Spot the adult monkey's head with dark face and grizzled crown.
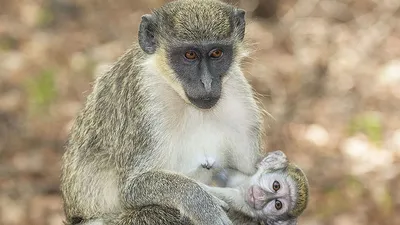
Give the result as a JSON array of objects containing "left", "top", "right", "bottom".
[{"left": 139, "top": 0, "right": 245, "bottom": 109}]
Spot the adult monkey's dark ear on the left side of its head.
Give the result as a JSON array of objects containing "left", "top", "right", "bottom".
[{"left": 139, "top": 14, "right": 157, "bottom": 54}]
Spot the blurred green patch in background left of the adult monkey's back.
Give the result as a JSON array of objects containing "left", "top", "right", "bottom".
[{"left": 26, "top": 70, "right": 57, "bottom": 111}]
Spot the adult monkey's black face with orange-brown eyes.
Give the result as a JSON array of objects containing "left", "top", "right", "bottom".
[{"left": 168, "top": 43, "right": 233, "bottom": 109}]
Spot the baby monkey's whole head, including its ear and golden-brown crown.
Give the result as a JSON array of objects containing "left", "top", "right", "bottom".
[{"left": 245, "top": 151, "right": 309, "bottom": 225}]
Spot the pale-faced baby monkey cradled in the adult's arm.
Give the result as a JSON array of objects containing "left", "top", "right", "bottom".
[{"left": 202, "top": 150, "right": 309, "bottom": 225}]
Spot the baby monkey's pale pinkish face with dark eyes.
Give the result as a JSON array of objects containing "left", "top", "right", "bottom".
[{"left": 245, "top": 169, "right": 296, "bottom": 224}]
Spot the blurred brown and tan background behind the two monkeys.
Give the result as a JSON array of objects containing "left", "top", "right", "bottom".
[{"left": 0, "top": 0, "right": 400, "bottom": 225}]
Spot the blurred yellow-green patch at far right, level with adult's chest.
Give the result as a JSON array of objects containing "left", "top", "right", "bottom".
[{"left": 349, "top": 112, "right": 383, "bottom": 145}]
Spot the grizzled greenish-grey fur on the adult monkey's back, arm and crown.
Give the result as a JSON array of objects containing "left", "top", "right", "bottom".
[{"left": 61, "top": 0, "right": 261, "bottom": 225}]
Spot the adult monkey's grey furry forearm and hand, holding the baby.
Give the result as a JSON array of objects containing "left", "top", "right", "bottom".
[{"left": 123, "top": 171, "right": 232, "bottom": 225}]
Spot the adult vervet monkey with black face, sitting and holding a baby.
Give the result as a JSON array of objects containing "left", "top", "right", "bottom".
[{"left": 61, "top": 0, "right": 262, "bottom": 225}]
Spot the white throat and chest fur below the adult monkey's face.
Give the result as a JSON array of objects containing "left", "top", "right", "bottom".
[{"left": 144, "top": 55, "right": 260, "bottom": 182}]
